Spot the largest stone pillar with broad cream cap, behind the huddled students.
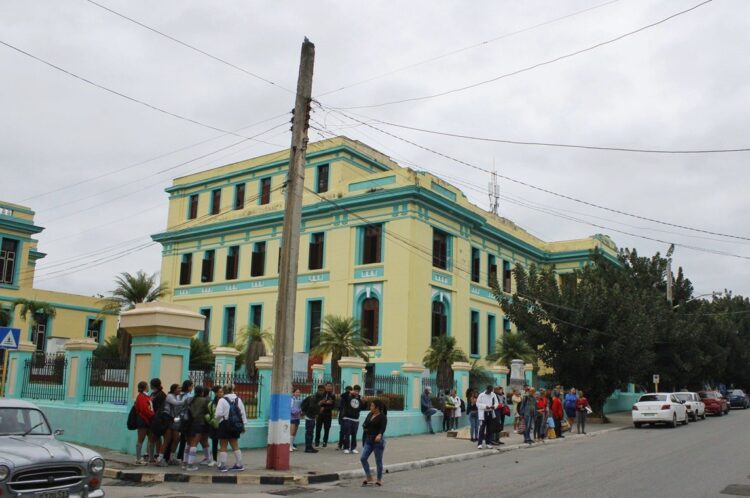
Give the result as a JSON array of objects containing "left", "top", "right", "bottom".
[{"left": 120, "top": 302, "right": 205, "bottom": 398}]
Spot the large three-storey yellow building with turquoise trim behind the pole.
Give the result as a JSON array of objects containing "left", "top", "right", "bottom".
[{"left": 153, "top": 137, "right": 616, "bottom": 374}]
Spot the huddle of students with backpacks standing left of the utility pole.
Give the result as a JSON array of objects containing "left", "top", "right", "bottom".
[{"left": 128, "top": 378, "right": 247, "bottom": 472}]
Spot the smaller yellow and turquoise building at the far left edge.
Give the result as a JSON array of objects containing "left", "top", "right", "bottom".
[{"left": 0, "top": 201, "right": 117, "bottom": 353}]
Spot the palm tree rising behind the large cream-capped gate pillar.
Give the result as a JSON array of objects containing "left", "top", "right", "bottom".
[{"left": 102, "top": 270, "right": 169, "bottom": 358}]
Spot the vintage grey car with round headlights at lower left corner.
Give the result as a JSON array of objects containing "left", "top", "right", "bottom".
[{"left": 0, "top": 399, "right": 104, "bottom": 498}]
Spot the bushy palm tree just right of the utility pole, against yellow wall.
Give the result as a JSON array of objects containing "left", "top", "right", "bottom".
[{"left": 310, "top": 315, "right": 370, "bottom": 379}]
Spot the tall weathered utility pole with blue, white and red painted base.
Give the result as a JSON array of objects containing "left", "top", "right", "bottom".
[{"left": 266, "top": 38, "right": 315, "bottom": 470}]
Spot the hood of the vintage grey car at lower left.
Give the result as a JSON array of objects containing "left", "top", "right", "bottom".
[{"left": 0, "top": 436, "right": 99, "bottom": 468}]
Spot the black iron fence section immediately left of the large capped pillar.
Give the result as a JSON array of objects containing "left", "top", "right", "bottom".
[{"left": 83, "top": 358, "right": 130, "bottom": 405}]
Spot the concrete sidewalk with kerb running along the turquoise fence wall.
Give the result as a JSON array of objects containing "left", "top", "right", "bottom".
[{"left": 98, "top": 412, "right": 631, "bottom": 484}]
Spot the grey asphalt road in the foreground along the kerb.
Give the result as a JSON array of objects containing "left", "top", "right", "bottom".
[{"left": 107, "top": 410, "right": 750, "bottom": 498}]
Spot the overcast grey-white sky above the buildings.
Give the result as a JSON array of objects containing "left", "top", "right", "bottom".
[{"left": 0, "top": 0, "right": 750, "bottom": 295}]
